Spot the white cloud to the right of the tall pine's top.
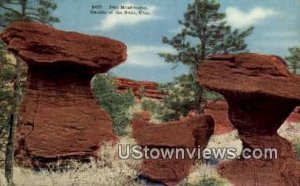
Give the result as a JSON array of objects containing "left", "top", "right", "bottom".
[{"left": 225, "top": 7, "right": 277, "bottom": 28}]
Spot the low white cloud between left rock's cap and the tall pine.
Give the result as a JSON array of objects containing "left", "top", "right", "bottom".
[{"left": 124, "top": 45, "right": 174, "bottom": 67}]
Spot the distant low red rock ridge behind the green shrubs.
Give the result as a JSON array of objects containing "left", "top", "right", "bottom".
[{"left": 115, "top": 77, "right": 164, "bottom": 100}]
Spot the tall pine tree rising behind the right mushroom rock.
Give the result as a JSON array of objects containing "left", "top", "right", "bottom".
[{"left": 159, "top": 0, "right": 254, "bottom": 113}]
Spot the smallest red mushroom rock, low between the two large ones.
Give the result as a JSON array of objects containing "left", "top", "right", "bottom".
[{"left": 132, "top": 115, "right": 214, "bottom": 185}]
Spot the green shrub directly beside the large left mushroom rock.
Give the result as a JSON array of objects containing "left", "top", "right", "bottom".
[{"left": 92, "top": 75, "right": 134, "bottom": 136}]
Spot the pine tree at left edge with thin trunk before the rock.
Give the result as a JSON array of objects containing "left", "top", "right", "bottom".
[{"left": 0, "top": 0, "right": 59, "bottom": 186}]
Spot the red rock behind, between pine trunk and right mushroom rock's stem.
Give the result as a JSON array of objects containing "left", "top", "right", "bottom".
[{"left": 204, "top": 100, "right": 234, "bottom": 135}]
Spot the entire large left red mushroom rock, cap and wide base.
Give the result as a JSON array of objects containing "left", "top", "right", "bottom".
[{"left": 1, "top": 22, "right": 126, "bottom": 167}]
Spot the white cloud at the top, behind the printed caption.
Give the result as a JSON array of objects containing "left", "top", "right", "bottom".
[{"left": 95, "top": 2, "right": 159, "bottom": 31}]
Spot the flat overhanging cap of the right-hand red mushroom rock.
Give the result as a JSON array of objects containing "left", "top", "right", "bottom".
[{"left": 198, "top": 53, "right": 300, "bottom": 101}]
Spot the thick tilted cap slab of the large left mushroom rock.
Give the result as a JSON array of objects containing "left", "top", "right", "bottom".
[{"left": 0, "top": 22, "right": 127, "bottom": 72}]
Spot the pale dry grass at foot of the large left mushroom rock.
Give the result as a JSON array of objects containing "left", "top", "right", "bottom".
[{"left": 0, "top": 138, "right": 142, "bottom": 186}]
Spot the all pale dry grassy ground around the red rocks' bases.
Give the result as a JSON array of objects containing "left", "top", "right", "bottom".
[{"left": 0, "top": 124, "right": 300, "bottom": 186}]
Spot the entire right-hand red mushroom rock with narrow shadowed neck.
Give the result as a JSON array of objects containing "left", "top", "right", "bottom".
[{"left": 198, "top": 54, "right": 300, "bottom": 185}]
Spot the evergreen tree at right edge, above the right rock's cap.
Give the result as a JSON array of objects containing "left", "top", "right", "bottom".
[{"left": 285, "top": 47, "right": 300, "bottom": 75}]
